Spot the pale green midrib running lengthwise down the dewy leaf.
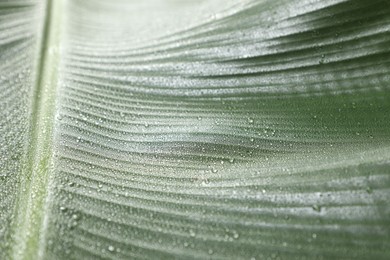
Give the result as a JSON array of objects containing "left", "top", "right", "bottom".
[{"left": 10, "top": 0, "right": 62, "bottom": 259}]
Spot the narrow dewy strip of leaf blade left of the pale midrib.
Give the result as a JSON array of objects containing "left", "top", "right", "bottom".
[{"left": 0, "top": 0, "right": 42, "bottom": 259}]
